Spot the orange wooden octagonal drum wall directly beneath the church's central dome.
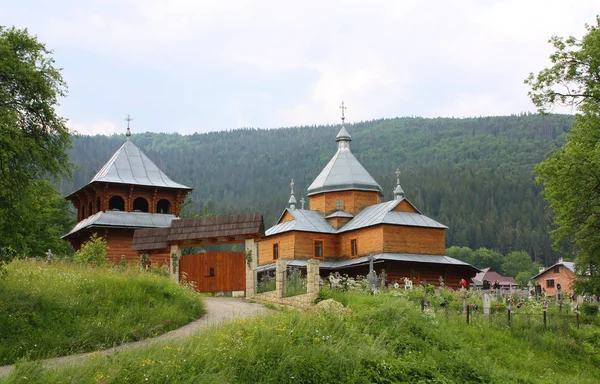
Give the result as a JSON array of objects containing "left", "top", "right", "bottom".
[{"left": 308, "top": 191, "right": 381, "bottom": 216}]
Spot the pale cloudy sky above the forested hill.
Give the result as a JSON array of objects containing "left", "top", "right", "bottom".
[{"left": 0, "top": 0, "right": 600, "bottom": 135}]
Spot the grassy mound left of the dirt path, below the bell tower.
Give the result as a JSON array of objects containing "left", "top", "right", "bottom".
[{"left": 0, "top": 262, "right": 205, "bottom": 365}]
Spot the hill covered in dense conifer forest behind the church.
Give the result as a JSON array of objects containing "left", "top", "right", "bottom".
[{"left": 60, "top": 114, "right": 573, "bottom": 264}]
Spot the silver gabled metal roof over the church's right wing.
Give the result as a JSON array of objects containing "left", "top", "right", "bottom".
[{"left": 338, "top": 199, "right": 448, "bottom": 233}]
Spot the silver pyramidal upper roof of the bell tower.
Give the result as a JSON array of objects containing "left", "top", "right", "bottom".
[{"left": 90, "top": 140, "right": 191, "bottom": 189}]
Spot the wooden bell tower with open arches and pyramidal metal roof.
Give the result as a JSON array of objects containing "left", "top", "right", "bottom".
[{"left": 63, "top": 121, "right": 192, "bottom": 264}]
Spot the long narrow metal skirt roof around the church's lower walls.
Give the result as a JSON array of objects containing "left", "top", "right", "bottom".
[{"left": 256, "top": 253, "right": 478, "bottom": 272}]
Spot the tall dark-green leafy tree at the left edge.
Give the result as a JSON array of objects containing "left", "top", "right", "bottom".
[{"left": 0, "top": 26, "right": 70, "bottom": 253}]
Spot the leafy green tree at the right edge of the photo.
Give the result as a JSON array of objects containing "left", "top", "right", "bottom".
[{"left": 526, "top": 17, "right": 600, "bottom": 294}]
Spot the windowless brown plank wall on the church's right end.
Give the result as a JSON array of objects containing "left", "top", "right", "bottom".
[{"left": 383, "top": 225, "right": 446, "bottom": 255}]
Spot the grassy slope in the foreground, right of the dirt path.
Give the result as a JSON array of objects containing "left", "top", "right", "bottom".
[{"left": 6, "top": 293, "right": 600, "bottom": 383}]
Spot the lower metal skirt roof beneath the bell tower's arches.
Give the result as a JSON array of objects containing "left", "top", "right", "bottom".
[{"left": 63, "top": 211, "right": 177, "bottom": 238}]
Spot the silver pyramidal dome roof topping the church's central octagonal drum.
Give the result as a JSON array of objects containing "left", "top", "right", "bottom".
[{"left": 308, "top": 125, "right": 383, "bottom": 196}]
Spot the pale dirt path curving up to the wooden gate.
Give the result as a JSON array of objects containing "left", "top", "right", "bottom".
[{"left": 0, "top": 297, "right": 269, "bottom": 378}]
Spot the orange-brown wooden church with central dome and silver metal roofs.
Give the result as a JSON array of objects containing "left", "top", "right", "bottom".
[{"left": 258, "top": 105, "right": 478, "bottom": 288}]
